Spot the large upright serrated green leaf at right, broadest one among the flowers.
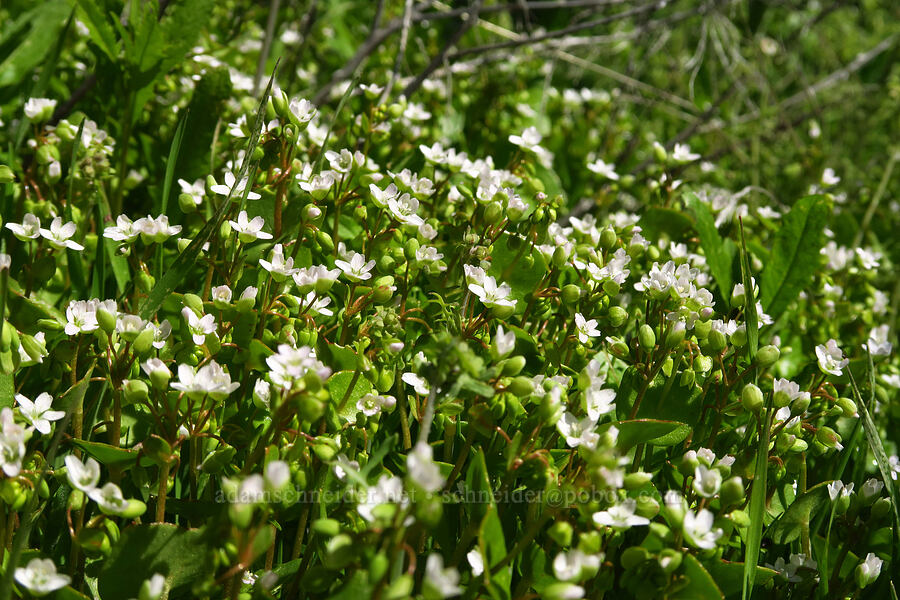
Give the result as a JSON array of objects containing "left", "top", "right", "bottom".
[{"left": 760, "top": 195, "right": 831, "bottom": 319}]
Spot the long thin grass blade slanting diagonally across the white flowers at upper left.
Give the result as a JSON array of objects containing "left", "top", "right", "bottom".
[{"left": 140, "top": 63, "right": 278, "bottom": 319}]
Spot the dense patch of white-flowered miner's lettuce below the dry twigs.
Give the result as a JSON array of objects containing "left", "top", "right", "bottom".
[{"left": 0, "top": 1, "right": 900, "bottom": 600}]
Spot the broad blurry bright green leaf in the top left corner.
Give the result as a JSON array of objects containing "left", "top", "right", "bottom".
[{"left": 0, "top": 0, "right": 72, "bottom": 88}]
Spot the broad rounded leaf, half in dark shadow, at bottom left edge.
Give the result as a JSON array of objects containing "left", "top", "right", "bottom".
[{"left": 99, "top": 523, "right": 220, "bottom": 598}]
